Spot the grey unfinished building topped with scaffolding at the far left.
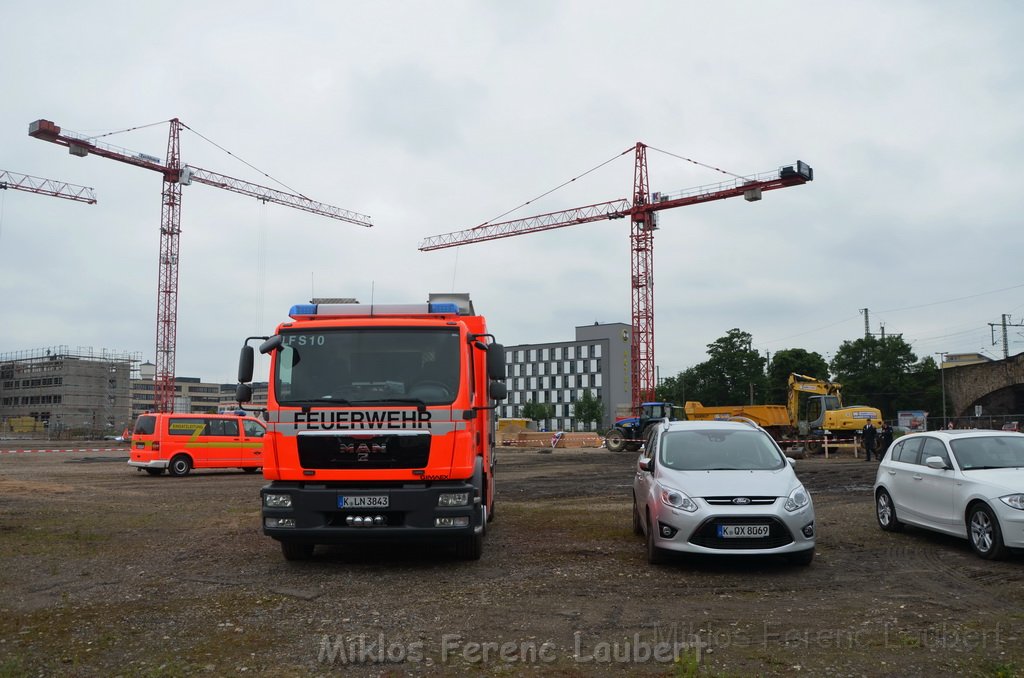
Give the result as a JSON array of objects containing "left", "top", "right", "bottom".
[{"left": 0, "top": 346, "right": 141, "bottom": 438}]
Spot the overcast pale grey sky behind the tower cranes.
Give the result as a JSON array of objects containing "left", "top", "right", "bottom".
[{"left": 0, "top": 0, "right": 1024, "bottom": 382}]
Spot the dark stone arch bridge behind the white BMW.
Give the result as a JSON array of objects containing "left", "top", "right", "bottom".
[{"left": 943, "top": 353, "right": 1024, "bottom": 417}]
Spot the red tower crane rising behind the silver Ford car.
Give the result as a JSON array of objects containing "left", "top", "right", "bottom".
[{"left": 420, "top": 141, "right": 814, "bottom": 411}]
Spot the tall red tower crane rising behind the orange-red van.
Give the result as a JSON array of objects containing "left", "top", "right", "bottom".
[{"left": 29, "top": 118, "right": 373, "bottom": 412}]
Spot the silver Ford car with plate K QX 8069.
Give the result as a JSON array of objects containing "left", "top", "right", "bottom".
[{"left": 633, "top": 420, "right": 814, "bottom": 565}]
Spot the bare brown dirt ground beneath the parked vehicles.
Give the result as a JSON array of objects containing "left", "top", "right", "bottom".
[{"left": 0, "top": 449, "right": 1024, "bottom": 676}]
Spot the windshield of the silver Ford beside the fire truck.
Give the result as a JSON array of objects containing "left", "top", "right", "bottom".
[{"left": 660, "top": 429, "right": 785, "bottom": 471}]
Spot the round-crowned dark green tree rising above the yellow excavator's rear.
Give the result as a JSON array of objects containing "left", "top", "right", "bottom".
[{"left": 830, "top": 335, "right": 918, "bottom": 418}]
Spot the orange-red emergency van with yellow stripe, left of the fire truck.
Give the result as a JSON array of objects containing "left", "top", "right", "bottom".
[{"left": 128, "top": 413, "right": 266, "bottom": 476}]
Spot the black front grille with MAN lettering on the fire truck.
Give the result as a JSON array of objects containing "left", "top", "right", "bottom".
[{"left": 298, "top": 433, "right": 430, "bottom": 469}]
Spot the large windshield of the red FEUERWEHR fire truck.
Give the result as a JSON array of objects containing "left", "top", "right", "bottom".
[{"left": 273, "top": 328, "right": 460, "bottom": 406}]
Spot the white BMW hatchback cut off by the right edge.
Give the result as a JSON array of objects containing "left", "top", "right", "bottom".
[{"left": 874, "top": 430, "right": 1024, "bottom": 558}]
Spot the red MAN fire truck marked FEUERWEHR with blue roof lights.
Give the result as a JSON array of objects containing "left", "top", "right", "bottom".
[{"left": 238, "top": 294, "right": 507, "bottom": 560}]
